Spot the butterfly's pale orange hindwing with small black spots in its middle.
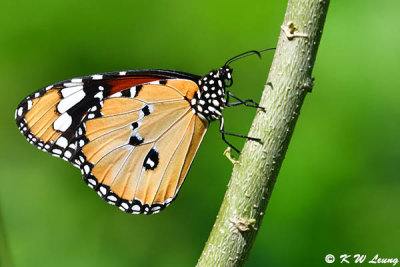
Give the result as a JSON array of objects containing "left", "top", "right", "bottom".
[{"left": 75, "top": 79, "right": 208, "bottom": 214}]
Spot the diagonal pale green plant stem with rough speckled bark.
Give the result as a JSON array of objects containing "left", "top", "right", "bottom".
[{"left": 197, "top": 0, "right": 329, "bottom": 266}]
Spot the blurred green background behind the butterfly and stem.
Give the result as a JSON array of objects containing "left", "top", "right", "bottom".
[{"left": 0, "top": 0, "right": 400, "bottom": 267}]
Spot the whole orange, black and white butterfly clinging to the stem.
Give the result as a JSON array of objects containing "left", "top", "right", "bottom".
[{"left": 15, "top": 49, "right": 269, "bottom": 214}]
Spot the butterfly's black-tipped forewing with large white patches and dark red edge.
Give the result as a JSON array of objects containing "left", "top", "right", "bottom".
[{"left": 15, "top": 70, "right": 197, "bottom": 165}]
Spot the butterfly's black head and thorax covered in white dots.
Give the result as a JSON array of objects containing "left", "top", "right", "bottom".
[{"left": 190, "top": 66, "right": 232, "bottom": 121}]
